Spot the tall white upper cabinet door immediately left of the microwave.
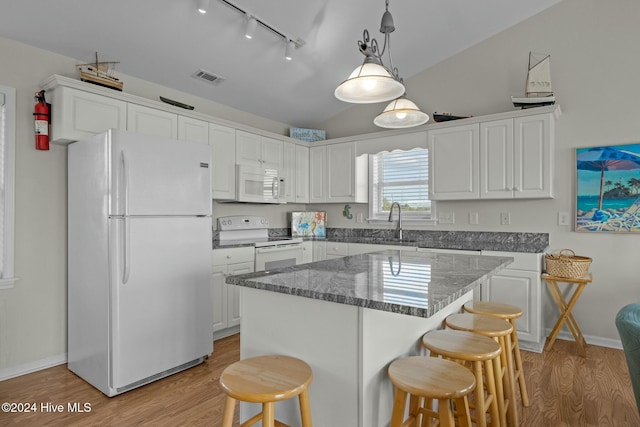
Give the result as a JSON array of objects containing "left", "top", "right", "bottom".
[{"left": 209, "top": 123, "right": 236, "bottom": 200}]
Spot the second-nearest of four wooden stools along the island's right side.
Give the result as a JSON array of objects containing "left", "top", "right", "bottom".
[{"left": 422, "top": 330, "right": 506, "bottom": 427}]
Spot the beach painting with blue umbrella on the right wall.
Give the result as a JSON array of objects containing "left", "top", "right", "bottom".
[{"left": 576, "top": 143, "right": 640, "bottom": 233}]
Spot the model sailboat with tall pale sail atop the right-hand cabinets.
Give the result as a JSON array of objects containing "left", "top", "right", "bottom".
[{"left": 511, "top": 52, "right": 556, "bottom": 108}]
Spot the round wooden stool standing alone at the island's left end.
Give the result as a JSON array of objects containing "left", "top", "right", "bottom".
[{"left": 220, "top": 356, "right": 313, "bottom": 427}]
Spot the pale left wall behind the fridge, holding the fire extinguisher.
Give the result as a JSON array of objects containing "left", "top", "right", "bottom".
[{"left": 0, "top": 38, "right": 289, "bottom": 380}]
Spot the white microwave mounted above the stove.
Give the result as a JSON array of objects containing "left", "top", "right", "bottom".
[{"left": 236, "top": 165, "right": 285, "bottom": 203}]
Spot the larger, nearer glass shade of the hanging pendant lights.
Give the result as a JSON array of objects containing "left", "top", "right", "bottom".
[{"left": 335, "top": 57, "right": 404, "bottom": 104}]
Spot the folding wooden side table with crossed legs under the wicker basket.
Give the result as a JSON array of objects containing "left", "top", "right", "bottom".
[{"left": 541, "top": 273, "right": 592, "bottom": 357}]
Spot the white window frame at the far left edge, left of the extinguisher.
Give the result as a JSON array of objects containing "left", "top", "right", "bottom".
[{"left": 0, "top": 85, "right": 18, "bottom": 290}]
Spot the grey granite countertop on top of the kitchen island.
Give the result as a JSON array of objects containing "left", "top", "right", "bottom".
[{"left": 226, "top": 250, "right": 513, "bottom": 317}]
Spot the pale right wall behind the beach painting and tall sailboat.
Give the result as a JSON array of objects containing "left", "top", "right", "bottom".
[{"left": 321, "top": 0, "right": 640, "bottom": 345}]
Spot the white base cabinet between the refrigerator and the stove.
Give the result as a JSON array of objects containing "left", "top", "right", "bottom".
[{"left": 211, "top": 247, "right": 254, "bottom": 338}]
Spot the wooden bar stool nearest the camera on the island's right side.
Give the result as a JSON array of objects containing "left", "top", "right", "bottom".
[{"left": 388, "top": 356, "right": 476, "bottom": 427}]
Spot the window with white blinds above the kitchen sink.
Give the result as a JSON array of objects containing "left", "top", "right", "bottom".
[{"left": 369, "top": 148, "right": 433, "bottom": 223}]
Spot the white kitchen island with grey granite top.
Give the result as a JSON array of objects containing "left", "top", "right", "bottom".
[{"left": 226, "top": 250, "right": 512, "bottom": 427}]
